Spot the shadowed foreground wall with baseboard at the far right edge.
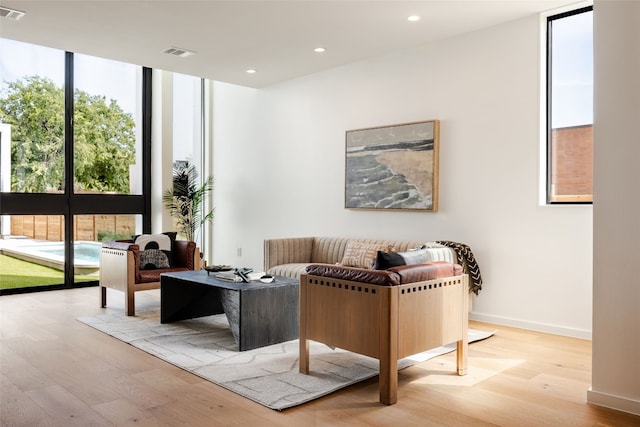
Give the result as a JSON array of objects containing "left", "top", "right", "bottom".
[{"left": 588, "top": 1, "right": 640, "bottom": 415}]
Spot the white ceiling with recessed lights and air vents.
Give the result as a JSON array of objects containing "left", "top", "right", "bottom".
[{"left": 0, "top": 0, "right": 578, "bottom": 88}]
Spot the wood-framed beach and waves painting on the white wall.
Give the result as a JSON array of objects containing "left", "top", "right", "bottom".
[{"left": 345, "top": 120, "right": 439, "bottom": 212}]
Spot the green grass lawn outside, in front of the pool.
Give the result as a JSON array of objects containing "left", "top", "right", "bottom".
[{"left": 0, "top": 255, "right": 98, "bottom": 289}]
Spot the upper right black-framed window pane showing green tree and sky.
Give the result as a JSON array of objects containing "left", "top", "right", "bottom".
[{"left": 73, "top": 54, "right": 142, "bottom": 195}]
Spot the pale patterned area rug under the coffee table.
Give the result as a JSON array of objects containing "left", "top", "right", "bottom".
[{"left": 78, "top": 296, "right": 493, "bottom": 410}]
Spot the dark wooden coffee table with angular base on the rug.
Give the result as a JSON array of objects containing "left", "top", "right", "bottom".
[{"left": 160, "top": 270, "right": 299, "bottom": 351}]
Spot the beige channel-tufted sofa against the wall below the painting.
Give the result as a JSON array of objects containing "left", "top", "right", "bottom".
[{"left": 264, "top": 237, "right": 458, "bottom": 279}]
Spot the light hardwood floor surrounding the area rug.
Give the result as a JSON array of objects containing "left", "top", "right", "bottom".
[{"left": 0, "top": 288, "right": 640, "bottom": 427}]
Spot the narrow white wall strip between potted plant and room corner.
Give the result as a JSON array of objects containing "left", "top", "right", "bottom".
[{"left": 207, "top": 82, "right": 258, "bottom": 268}]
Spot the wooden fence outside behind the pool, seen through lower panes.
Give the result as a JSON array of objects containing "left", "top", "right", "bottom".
[{"left": 11, "top": 215, "right": 136, "bottom": 242}]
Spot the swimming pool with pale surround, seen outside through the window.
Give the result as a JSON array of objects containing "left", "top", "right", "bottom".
[{"left": 0, "top": 240, "right": 102, "bottom": 274}]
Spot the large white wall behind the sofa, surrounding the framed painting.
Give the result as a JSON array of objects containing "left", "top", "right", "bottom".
[{"left": 213, "top": 16, "right": 592, "bottom": 337}]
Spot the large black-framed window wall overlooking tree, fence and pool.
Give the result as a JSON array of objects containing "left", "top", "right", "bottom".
[{"left": 0, "top": 39, "right": 151, "bottom": 293}]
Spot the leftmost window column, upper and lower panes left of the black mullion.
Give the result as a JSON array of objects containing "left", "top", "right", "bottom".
[{"left": 0, "top": 39, "right": 65, "bottom": 291}]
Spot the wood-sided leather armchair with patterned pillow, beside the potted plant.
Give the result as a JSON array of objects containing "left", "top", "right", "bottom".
[{"left": 100, "top": 233, "right": 200, "bottom": 316}]
